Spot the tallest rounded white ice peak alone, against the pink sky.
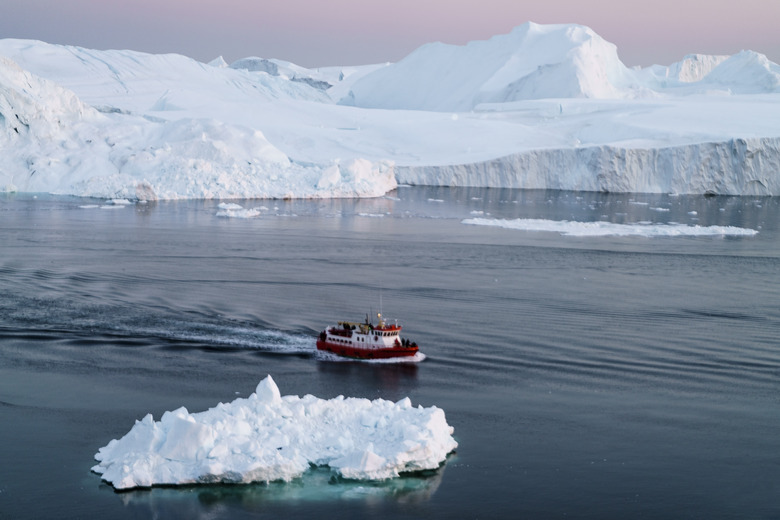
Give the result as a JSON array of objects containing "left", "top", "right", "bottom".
[{"left": 341, "top": 23, "right": 640, "bottom": 112}]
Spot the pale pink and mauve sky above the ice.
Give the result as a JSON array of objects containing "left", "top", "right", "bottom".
[{"left": 0, "top": 0, "right": 780, "bottom": 67}]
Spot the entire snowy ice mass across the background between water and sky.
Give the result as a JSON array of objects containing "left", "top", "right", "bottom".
[{"left": 0, "top": 22, "right": 780, "bottom": 201}]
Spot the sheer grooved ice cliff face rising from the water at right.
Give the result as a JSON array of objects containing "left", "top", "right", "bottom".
[{"left": 395, "top": 137, "right": 780, "bottom": 196}]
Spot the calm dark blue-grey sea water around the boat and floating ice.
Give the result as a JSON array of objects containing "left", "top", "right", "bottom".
[{"left": 0, "top": 188, "right": 780, "bottom": 518}]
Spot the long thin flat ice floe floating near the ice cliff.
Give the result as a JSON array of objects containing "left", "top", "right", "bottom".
[{"left": 462, "top": 218, "right": 758, "bottom": 237}]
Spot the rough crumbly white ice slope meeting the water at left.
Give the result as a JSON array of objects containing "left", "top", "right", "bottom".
[{"left": 0, "top": 51, "right": 396, "bottom": 200}]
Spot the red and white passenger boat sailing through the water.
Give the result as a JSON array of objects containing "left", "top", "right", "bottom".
[{"left": 317, "top": 314, "right": 419, "bottom": 359}]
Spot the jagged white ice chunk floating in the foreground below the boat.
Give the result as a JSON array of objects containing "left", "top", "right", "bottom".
[{"left": 92, "top": 376, "right": 458, "bottom": 489}]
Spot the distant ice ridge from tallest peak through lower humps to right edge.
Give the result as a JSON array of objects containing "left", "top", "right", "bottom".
[{"left": 340, "top": 22, "right": 780, "bottom": 112}]
